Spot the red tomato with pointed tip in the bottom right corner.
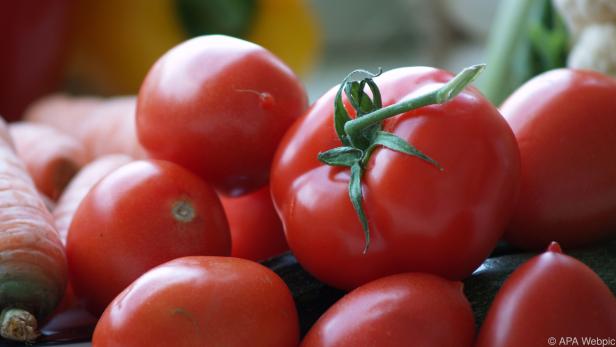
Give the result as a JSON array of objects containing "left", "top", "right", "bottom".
[{"left": 476, "top": 243, "right": 616, "bottom": 347}]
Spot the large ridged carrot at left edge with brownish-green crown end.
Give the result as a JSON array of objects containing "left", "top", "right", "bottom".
[{"left": 0, "top": 117, "right": 67, "bottom": 341}]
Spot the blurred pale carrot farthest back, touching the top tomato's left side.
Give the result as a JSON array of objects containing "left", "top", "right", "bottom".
[{"left": 25, "top": 95, "right": 145, "bottom": 160}]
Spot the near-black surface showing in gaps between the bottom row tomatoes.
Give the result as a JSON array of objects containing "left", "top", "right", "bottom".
[{"left": 9, "top": 240, "right": 616, "bottom": 347}]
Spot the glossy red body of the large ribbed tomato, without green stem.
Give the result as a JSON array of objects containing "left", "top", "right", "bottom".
[{"left": 271, "top": 67, "right": 519, "bottom": 289}]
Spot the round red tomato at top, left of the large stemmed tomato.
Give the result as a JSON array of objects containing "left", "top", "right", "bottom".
[{"left": 137, "top": 35, "right": 307, "bottom": 196}]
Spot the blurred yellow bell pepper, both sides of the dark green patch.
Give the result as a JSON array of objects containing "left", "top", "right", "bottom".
[{"left": 67, "top": 0, "right": 319, "bottom": 95}]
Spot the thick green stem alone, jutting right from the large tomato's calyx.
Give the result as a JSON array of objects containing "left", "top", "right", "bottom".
[{"left": 344, "top": 64, "right": 485, "bottom": 145}]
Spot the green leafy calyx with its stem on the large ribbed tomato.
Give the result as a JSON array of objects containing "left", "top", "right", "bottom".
[{"left": 318, "top": 64, "right": 485, "bottom": 254}]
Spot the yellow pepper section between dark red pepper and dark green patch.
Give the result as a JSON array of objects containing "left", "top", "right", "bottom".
[{"left": 68, "top": 0, "right": 185, "bottom": 94}]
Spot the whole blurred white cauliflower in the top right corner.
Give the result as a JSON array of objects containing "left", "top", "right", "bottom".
[{"left": 553, "top": 0, "right": 616, "bottom": 76}]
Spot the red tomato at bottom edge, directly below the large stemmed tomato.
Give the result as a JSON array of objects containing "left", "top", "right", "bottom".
[{"left": 300, "top": 273, "right": 475, "bottom": 347}]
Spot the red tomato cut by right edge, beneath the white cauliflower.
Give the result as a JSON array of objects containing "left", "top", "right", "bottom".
[{"left": 501, "top": 69, "right": 616, "bottom": 249}]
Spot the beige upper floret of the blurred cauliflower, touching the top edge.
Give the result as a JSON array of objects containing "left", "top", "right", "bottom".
[{"left": 553, "top": 0, "right": 616, "bottom": 38}]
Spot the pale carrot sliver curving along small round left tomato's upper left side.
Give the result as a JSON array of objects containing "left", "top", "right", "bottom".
[{"left": 53, "top": 154, "right": 133, "bottom": 244}]
